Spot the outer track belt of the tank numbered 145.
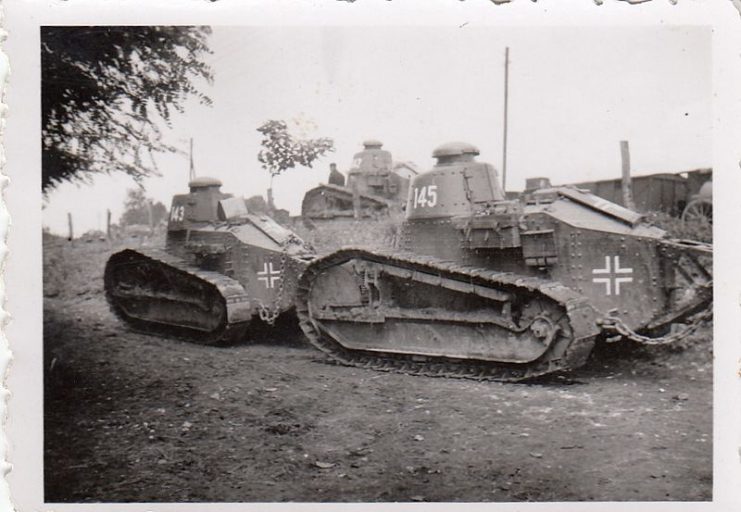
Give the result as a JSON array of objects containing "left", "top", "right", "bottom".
[{"left": 296, "top": 248, "right": 600, "bottom": 382}]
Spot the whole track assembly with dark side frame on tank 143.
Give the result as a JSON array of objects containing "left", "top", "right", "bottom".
[{"left": 104, "top": 249, "right": 252, "bottom": 345}]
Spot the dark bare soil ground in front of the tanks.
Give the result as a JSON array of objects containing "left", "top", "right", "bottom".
[{"left": 44, "top": 228, "right": 712, "bottom": 502}]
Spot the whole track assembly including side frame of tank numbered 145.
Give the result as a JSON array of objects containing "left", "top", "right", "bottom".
[{"left": 297, "top": 249, "right": 600, "bottom": 381}]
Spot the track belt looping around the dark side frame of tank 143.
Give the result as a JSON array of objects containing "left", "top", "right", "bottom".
[{"left": 105, "top": 249, "right": 252, "bottom": 345}]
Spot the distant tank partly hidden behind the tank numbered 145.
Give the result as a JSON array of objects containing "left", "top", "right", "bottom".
[{"left": 301, "top": 139, "right": 414, "bottom": 220}]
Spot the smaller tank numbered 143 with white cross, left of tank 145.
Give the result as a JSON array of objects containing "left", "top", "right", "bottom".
[{"left": 104, "top": 178, "right": 314, "bottom": 344}]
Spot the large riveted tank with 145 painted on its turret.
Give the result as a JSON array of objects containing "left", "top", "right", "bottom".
[{"left": 297, "top": 143, "right": 712, "bottom": 381}]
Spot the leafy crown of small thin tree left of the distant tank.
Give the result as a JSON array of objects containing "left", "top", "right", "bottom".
[{"left": 257, "top": 120, "right": 334, "bottom": 177}]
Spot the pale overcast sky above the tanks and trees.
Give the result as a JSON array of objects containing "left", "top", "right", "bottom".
[{"left": 44, "top": 26, "right": 712, "bottom": 234}]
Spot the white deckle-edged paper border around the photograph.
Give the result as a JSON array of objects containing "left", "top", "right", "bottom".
[{"left": 0, "top": 0, "right": 741, "bottom": 512}]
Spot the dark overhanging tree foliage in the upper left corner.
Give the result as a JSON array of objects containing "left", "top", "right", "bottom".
[{"left": 41, "top": 26, "right": 213, "bottom": 192}]
